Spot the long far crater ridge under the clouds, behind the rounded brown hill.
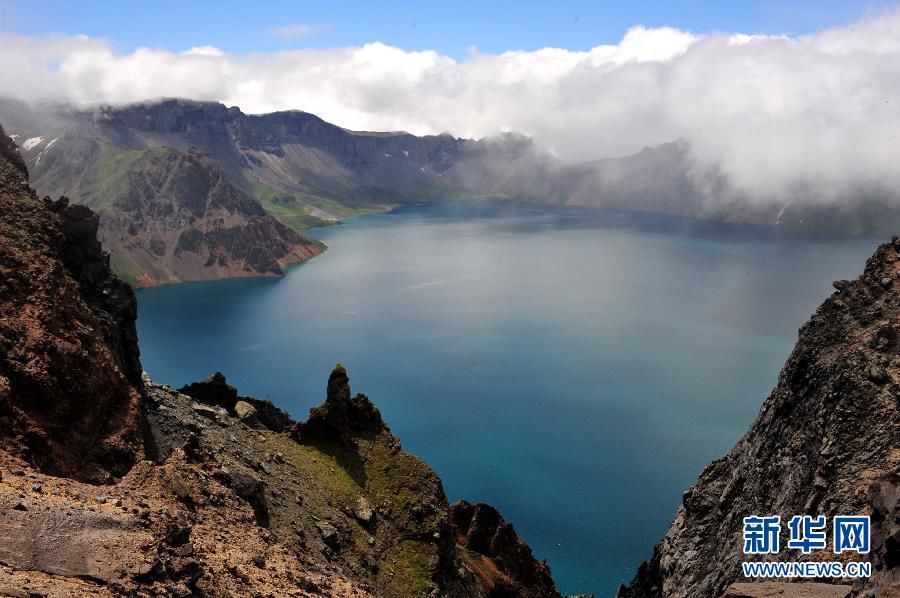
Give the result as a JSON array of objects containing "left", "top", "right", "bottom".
[{"left": 8, "top": 99, "right": 900, "bottom": 234}]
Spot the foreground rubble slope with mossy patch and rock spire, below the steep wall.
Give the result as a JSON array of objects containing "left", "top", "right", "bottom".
[{"left": 0, "top": 360, "right": 558, "bottom": 598}]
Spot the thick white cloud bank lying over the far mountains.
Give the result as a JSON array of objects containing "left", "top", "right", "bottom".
[{"left": 0, "top": 10, "right": 900, "bottom": 200}]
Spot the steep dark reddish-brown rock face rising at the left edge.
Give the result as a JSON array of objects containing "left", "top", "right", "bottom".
[{"left": 0, "top": 129, "right": 141, "bottom": 481}]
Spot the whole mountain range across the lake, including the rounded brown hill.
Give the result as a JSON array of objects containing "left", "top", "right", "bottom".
[{"left": 0, "top": 99, "right": 900, "bottom": 286}]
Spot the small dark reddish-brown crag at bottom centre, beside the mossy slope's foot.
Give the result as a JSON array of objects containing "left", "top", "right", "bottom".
[{"left": 450, "top": 500, "right": 560, "bottom": 598}]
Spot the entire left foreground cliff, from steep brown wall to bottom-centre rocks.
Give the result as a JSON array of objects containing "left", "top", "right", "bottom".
[{"left": 0, "top": 131, "right": 558, "bottom": 598}]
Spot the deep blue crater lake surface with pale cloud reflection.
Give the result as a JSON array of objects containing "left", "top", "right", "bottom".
[{"left": 138, "top": 203, "right": 875, "bottom": 596}]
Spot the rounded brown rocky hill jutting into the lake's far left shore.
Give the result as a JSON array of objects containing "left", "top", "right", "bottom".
[{"left": 87, "top": 147, "right": 324, "bottom": 286}]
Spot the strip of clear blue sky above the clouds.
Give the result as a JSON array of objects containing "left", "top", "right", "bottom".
[{"left": 7, "top": 0, "right": 895, "bottom": 59}]
